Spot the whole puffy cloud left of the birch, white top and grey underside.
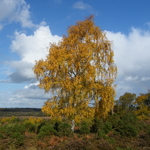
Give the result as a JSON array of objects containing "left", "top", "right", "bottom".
[{"left": 9, "top": 26, "right": 61, "bottom": 83}]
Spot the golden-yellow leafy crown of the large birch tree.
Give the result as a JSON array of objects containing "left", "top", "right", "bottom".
[{"left": 33, "top": 16, "right": 117, "bottom": 121}]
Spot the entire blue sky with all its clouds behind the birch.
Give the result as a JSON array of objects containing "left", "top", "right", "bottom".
[{"left": 0, "top": 0, "right": 150, "bottom": 108}]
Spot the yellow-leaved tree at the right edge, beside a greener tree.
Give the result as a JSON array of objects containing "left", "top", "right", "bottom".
[{"left": 134, "top": 93, "right": 150, "bottom": 120}]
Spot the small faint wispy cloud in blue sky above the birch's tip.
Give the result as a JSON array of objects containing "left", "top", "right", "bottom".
[{"left": 73, "top": 1, "right": 91, "bottom": 10}]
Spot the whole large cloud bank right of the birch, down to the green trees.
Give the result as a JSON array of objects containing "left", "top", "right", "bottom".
[{"left": 106, "top": 28, "right": 150, "bottom": 95}]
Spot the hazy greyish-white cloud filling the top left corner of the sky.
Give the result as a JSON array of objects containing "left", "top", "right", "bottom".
[{"left": 0, "top": 0, "right": 35, "bottom": 29}]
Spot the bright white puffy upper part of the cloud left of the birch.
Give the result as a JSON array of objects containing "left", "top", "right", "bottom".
[{"left": 11, "top": 26, "right": 61, "bottom": 63}]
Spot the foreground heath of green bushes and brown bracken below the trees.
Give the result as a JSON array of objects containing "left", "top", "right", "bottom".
[{"left": 0, "top": 113, "right": 150, "bottom": 150}]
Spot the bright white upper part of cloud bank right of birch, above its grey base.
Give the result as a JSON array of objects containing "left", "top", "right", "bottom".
[{"left": 107, "top": 28, "right": 150, "bottom": 75}]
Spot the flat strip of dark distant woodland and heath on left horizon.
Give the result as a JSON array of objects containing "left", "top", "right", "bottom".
[{"left": 0, "top": 108, "right": 45, "bottom": 117}]
